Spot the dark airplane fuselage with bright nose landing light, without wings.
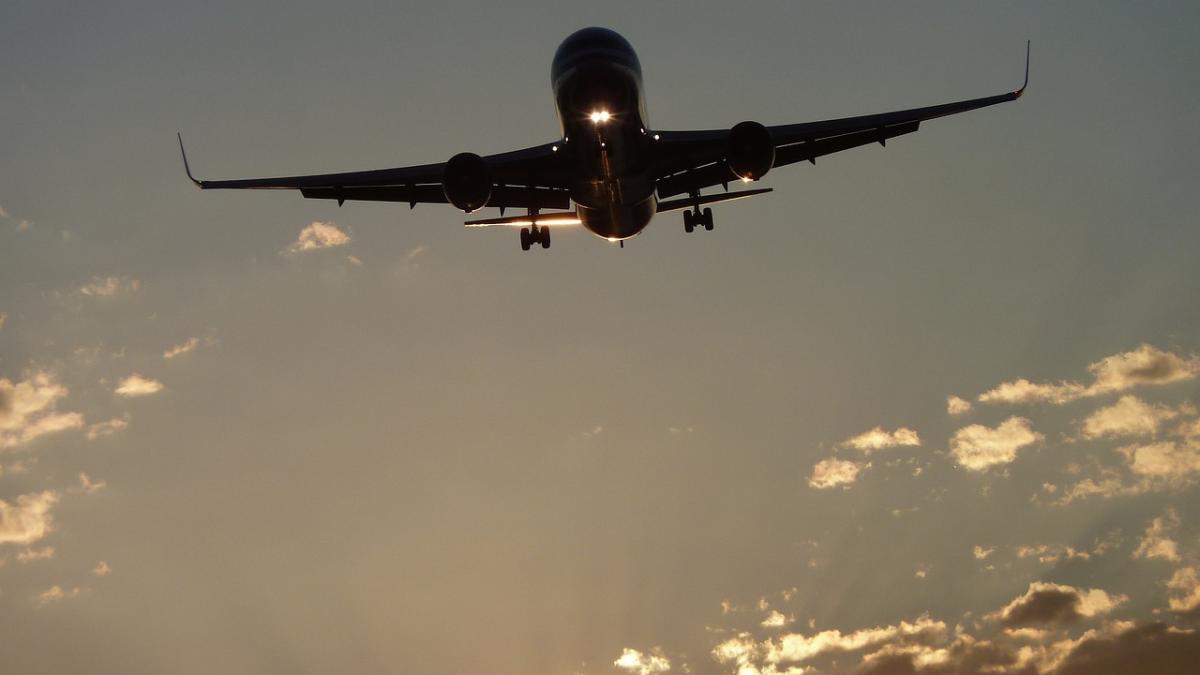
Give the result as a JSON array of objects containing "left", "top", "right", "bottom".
[{"left": 550, "top": 28, "right": 656, "bottom": 240}]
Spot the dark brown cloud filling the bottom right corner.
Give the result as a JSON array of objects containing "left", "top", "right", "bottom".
[{"left": 1055, "top": 622, "right": 1200, "bottom": 675}]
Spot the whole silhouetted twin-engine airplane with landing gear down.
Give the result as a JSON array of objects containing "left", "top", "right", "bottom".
[{"left": 178, "top": 28, "right": 1030, "bottom": 251}]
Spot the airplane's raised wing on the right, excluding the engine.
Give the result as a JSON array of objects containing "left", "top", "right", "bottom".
[{"left": 655, "top": 42, "right": 1030, "bottom": 198}]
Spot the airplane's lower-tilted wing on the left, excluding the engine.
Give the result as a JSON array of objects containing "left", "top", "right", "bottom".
[{"left": 179, "top": 136, "right": 570, "bottom": 209}]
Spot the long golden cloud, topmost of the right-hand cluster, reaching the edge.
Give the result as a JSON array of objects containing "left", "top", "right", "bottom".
[{"left": 979, "top": 345, "right": 1200, "bottom": 405}]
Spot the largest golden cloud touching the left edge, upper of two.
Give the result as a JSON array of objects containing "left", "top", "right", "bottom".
[{"left": 0, "top": 371, "right": 84, "bottom": 449}]
